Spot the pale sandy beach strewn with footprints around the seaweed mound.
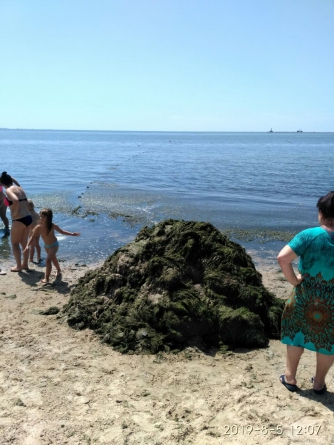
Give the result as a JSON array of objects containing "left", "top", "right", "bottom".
[{"left": 0, "top": 255, "right": 334, "bottom": 445}]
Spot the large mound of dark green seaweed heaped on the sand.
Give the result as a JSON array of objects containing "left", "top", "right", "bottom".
[{"left": 64, "top": 220, "right": 283, "bottom": 354}]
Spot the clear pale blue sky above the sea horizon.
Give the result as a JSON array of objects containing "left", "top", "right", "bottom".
[{"left": 0, "top": 0, "right": 334, "bottom": 131}]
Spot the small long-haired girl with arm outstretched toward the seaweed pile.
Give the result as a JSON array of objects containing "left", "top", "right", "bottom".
[{"left": 26, "top": 209, "right": 80, "bottom": 284}]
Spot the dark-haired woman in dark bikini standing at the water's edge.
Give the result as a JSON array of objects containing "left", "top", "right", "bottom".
[{"left": 0, "top": 172, "right": 32, "bottom": 272}]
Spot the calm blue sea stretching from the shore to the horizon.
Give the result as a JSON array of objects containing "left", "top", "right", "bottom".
[{"left": 0, "top": 129, "right": 334, "bottom": 264}]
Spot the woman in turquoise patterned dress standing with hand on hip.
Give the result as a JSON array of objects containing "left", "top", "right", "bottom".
[{"left": 277, "top": 191, "right": 334, "bottom": 394}]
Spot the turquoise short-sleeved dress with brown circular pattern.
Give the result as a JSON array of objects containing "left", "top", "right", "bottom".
[{"left": 282, "top": 227, "right": 334, "bottom": 355}]
